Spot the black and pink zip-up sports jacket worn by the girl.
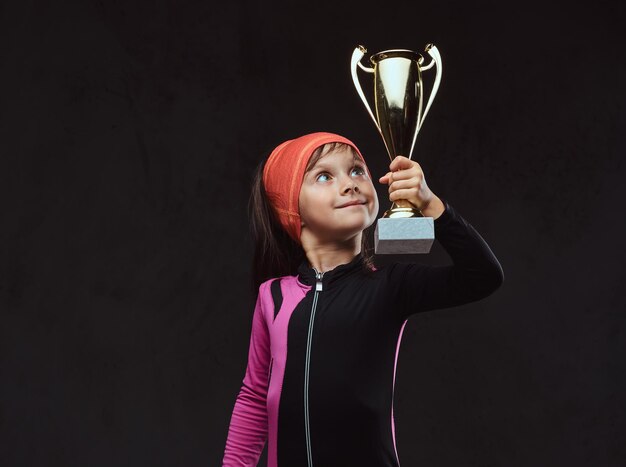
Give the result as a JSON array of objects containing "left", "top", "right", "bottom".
[{"left": 223, "top": 200, "right": 504, "bottom": 467}]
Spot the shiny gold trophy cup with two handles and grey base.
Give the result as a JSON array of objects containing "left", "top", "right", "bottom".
[{"left": 350, "top": 44, "right": 442, "bottom": 254}]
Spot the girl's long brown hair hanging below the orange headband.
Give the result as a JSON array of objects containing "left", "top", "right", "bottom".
[{"left": 248, "top": 142, "right": 374, "bottom": 295}]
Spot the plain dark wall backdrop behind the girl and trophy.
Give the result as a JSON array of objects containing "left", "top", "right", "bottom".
[{"left": 0, "top": 0, "right": 626, "bottom": 467}]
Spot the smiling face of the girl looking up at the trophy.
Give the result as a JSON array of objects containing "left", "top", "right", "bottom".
[{"left": 299, "top": 148, "right": 378, "bottom": 245}]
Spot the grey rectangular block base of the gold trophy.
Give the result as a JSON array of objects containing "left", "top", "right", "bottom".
[{"left": 374, "top": 217, "right": 435, "bottom": 255}]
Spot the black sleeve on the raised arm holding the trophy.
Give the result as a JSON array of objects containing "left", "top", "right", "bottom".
[{"left": 389, "top": 200, "right": 504, "bottom": 319}]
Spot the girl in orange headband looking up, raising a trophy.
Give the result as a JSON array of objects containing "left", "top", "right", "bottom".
[{"left": 222, "top": 132, "right": 504, "bottom": 467}]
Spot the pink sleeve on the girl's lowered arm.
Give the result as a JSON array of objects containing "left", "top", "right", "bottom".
[{"left": 222, "top": 283, "right": 271, "bottom": 467}]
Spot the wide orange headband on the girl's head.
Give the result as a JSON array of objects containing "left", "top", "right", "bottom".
[{"left": 263, "top": 132, "right": 371, "bottom": 243}]
